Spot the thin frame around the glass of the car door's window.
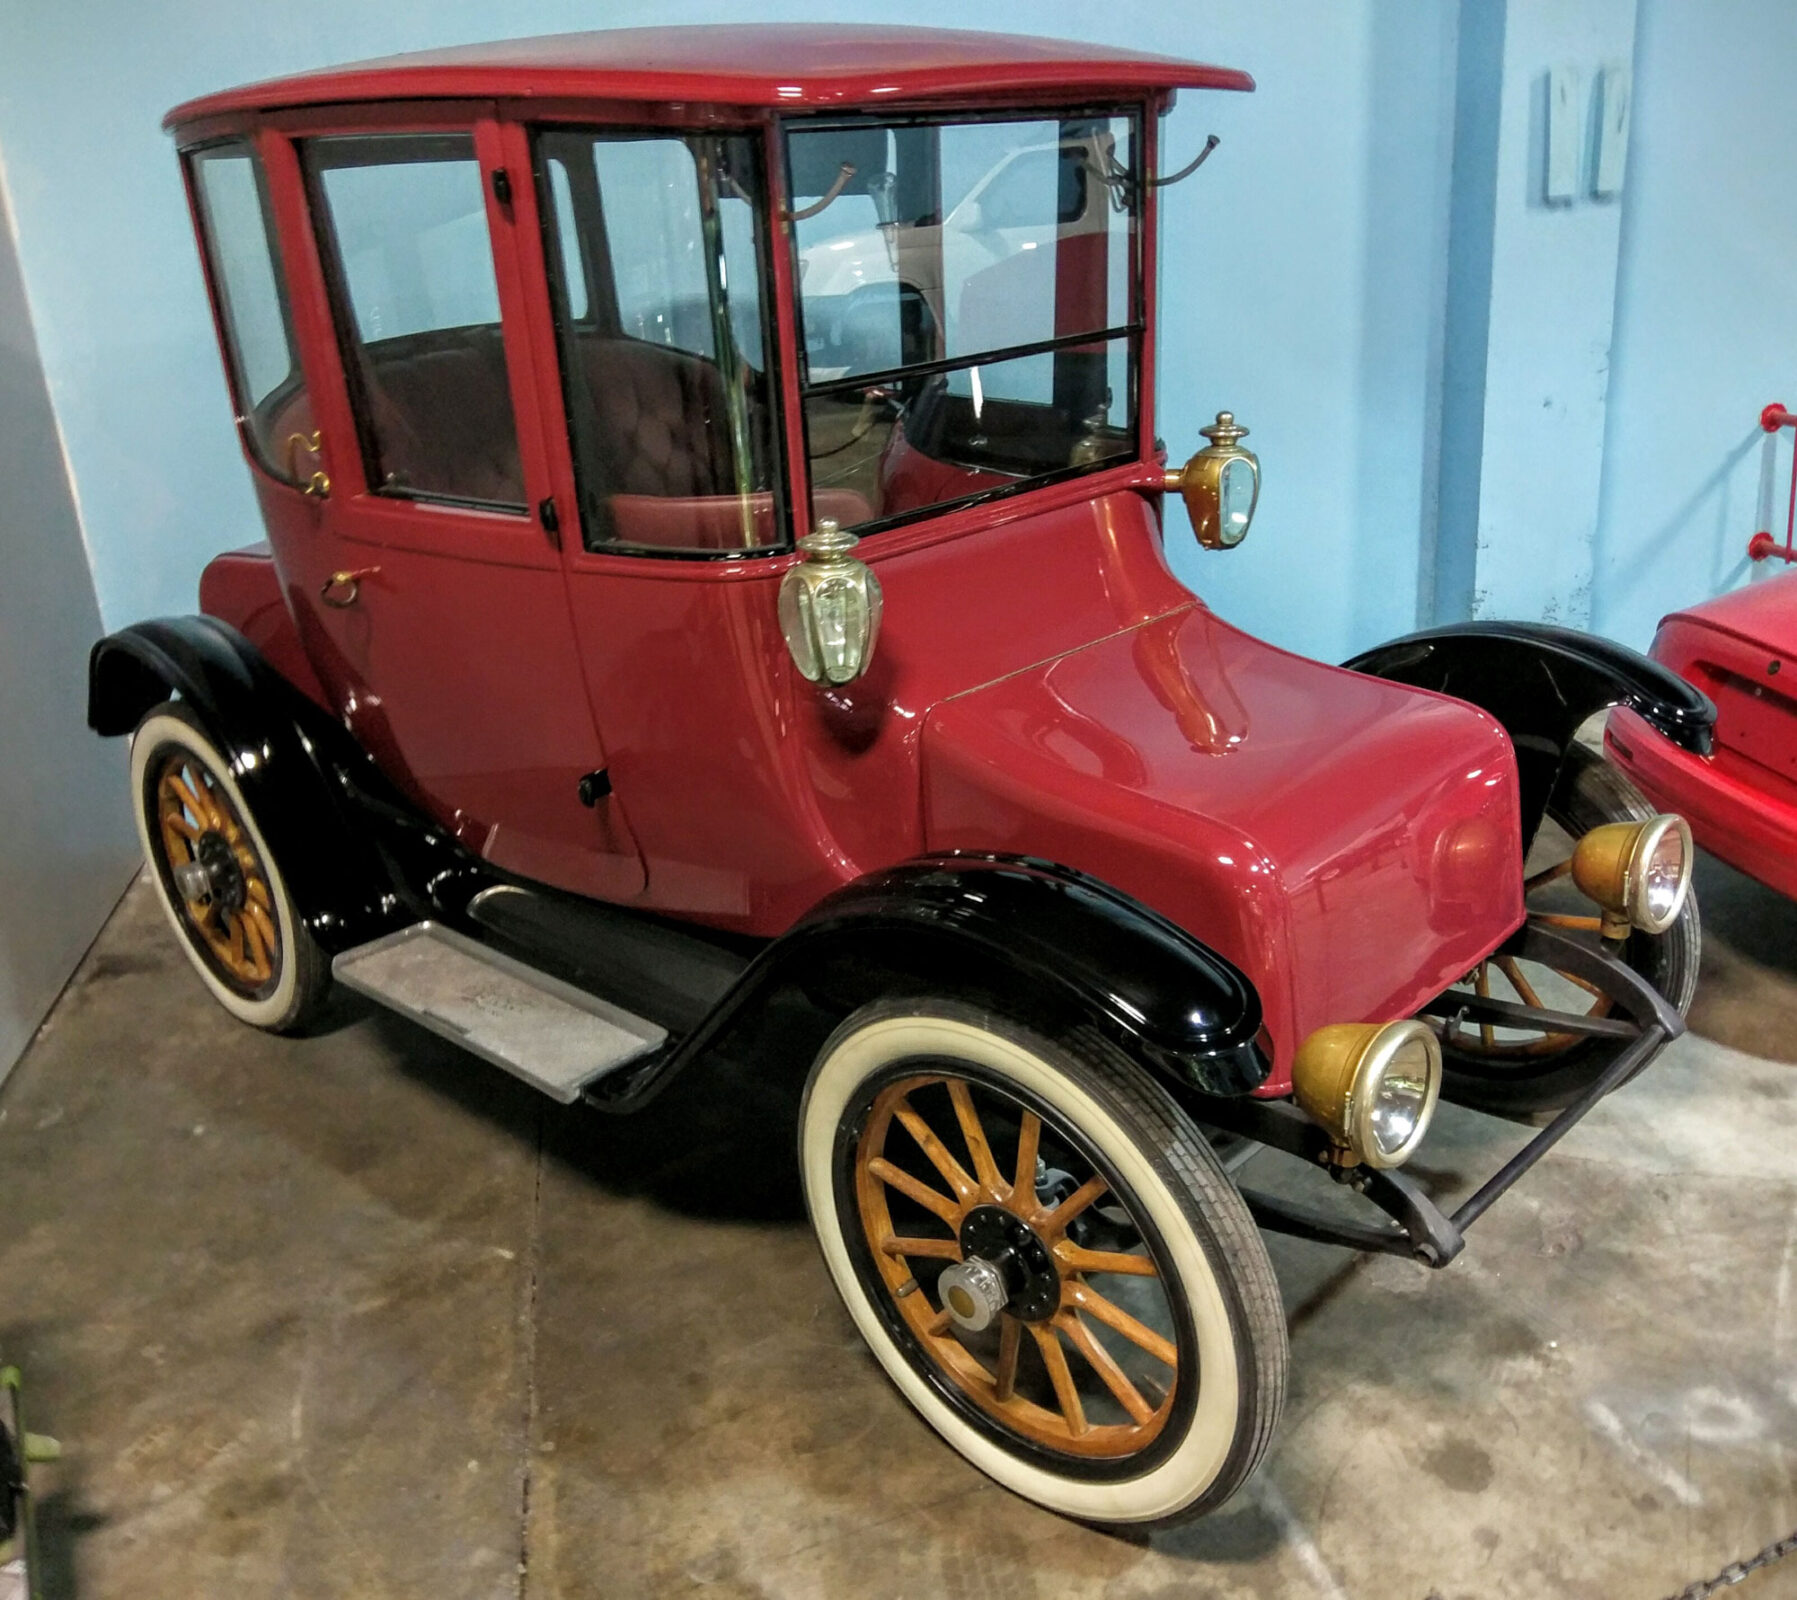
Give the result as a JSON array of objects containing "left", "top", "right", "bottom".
[{"left": 301, "top": 132, "right": 534, "bottom": 523}]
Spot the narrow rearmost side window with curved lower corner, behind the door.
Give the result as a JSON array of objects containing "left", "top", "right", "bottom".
[{"left": 192, "top": 144, "right": 313, "bottom": 482}]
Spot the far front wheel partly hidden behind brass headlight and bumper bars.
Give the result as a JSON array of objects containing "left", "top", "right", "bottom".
[{"left": 1441, "top": 744, "right": 1702, "bottom": 1115}]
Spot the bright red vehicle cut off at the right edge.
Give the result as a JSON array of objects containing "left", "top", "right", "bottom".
[{"left": 1605, "top": 572, "right": 1797, "bottom": 895}]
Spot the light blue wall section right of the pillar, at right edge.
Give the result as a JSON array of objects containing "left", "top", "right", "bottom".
[{"left": 1592, "top": 0, "right": 1797, "bottom": 647}]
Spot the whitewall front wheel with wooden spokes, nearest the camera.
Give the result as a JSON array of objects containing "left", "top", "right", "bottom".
[{"left": 800, "top": 1001, "right": 1287, "bottom": 1526}]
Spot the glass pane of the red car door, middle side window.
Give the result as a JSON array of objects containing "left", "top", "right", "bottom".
[{"left": 305, "top": 133, "right": 525, "bottom": 511}]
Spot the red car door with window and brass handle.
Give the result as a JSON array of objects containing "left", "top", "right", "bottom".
[{"left": 269, "top": 106, "right": 643, "bottom": 899}]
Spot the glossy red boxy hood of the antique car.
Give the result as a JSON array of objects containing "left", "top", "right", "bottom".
[{"left": 924, "top": 606, "right": 1522, "bottom": 1089}]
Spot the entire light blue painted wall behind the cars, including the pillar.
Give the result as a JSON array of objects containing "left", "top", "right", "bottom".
[{"left": 0, "top": 0, "right": 1797, "bottom": 658}]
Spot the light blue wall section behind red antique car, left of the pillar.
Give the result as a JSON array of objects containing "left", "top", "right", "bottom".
[{"left": 0, "top": 0, "right": 1456, "bottom": 656}]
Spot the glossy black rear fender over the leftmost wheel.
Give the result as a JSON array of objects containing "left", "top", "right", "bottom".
[{"left": 88, "top": 617, "right": 447, "bottom": 953}]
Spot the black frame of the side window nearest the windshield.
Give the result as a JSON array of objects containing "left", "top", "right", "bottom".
[{"left": 523, "top": 115, "right": 796, "bottom": 563}]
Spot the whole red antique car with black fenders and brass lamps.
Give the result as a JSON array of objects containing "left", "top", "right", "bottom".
[{"left": 90, "top": 27, "right": 1713, "bottom": 1524}]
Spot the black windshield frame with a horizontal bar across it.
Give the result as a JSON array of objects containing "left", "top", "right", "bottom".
[{"left": 775, "top": 99, "right": 1152, "bottom": 538}]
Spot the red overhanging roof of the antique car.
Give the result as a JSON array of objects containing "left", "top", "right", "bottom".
[{"left": 162, "top": 23, "right": 1254, "bottom": 129}]
